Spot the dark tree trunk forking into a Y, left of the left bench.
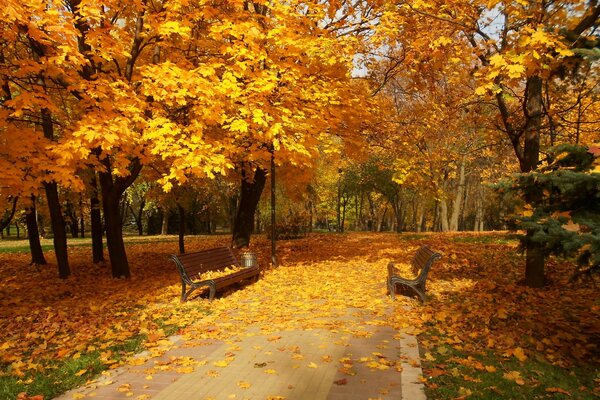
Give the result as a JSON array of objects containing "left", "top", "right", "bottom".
[{"left": 98, "top": 158, "right": 142, "bottom": 278}]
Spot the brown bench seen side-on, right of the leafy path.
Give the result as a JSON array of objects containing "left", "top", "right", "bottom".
[{"left": 387, "top": 246, "right": 442, "bottom": 302}]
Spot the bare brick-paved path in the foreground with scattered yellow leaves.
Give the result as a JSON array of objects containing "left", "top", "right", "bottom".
[{"left": 59, "top": 310, "right": 425, "bottom": 400}]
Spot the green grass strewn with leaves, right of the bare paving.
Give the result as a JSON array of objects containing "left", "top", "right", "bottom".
[{"left": 422, "top": 336, "right": 600, "bottom": 400}]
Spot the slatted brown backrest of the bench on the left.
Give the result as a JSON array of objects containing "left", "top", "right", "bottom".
[{"left": 171, "top": 247, "right": 240, "bottom": 278}]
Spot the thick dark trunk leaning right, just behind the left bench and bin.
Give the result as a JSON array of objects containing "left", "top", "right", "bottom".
[{"left": 232, "top": 167, "right": 267, "bottom": 248}]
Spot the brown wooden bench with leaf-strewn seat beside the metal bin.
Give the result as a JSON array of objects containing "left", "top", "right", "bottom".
[{"left": 169, "top": 247, "right": 260, "bottom": 302}]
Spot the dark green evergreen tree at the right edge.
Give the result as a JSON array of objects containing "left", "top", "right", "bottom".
[{"left": 496, "top": 144, "right": 600, "bottom": 279}]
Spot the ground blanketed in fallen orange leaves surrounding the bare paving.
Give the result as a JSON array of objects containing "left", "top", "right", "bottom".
[{"left": 0, "top": 233, "right": 600, "bottom": 399}]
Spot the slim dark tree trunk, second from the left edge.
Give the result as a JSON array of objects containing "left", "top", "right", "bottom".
[{"left": 44, "top": 182, "right": 71, "bottom": 279}]
